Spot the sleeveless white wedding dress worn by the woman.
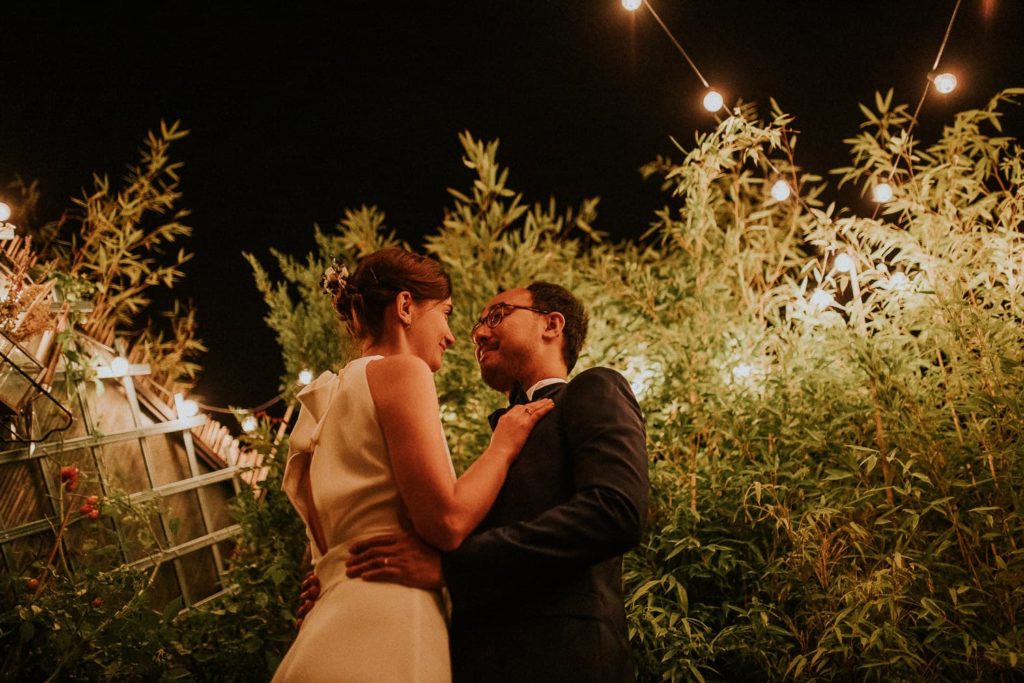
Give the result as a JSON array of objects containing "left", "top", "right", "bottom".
[{"left": 273, "top": 356, "right": 452, "bottom": 683}]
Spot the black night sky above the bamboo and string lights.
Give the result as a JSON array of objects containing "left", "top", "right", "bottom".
[{"left": 0, "top": 0, "right": 1024, "bottom": 413}]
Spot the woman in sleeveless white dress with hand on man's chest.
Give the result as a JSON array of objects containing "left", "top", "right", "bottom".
[{"left": 273, "top": 248, "right": 553, "bottom": 683}]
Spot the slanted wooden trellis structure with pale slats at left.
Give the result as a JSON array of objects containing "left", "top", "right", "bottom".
[{"left": 0, "top": 248, "right": 260, "bottom": 607}]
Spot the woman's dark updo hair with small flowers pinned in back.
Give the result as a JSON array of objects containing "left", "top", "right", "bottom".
[{"left": 323, "top": 247, "right": 452, "bottom": 341}]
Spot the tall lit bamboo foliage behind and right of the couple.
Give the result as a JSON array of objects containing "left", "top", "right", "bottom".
[{"left": 254, "top": 90, "right": 1024, "bottom": 680}]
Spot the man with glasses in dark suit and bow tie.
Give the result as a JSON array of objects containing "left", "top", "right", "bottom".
[{"left": 348, "top": 283, "right": 648, "bottom": 683}]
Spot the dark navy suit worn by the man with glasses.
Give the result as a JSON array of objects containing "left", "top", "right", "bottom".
[{"left": 442, "top": 368, "right": 648, "bottom": 683}]
